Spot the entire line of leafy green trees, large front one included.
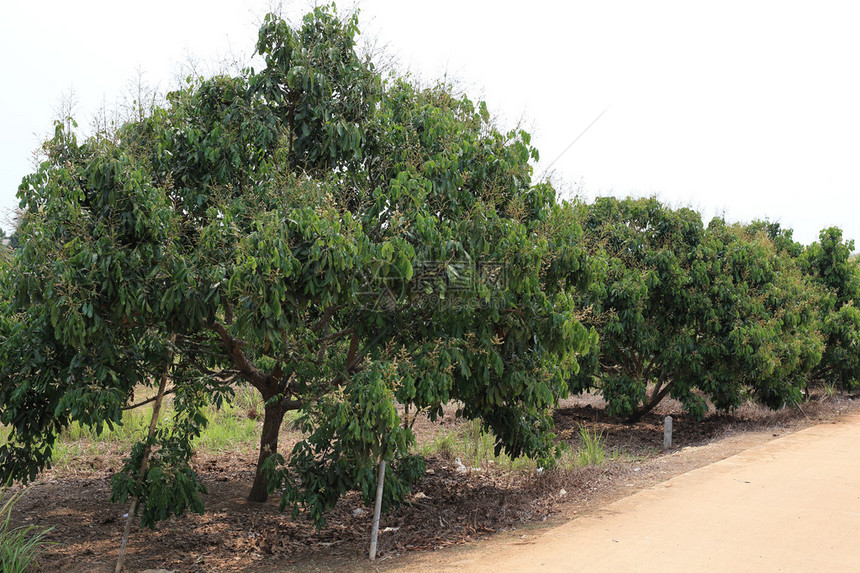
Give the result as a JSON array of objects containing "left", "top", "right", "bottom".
[{"left": 0, "top": 7, "right": 860, "bottom": 525}]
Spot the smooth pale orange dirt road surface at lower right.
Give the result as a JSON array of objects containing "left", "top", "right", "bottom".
[{"left": 396, "top": 415, "right": 860, "bottom": 573}]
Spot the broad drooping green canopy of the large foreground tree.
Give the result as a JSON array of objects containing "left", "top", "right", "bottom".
[{"left": 0, "top": 7, "right": 596, "bottom": 526}]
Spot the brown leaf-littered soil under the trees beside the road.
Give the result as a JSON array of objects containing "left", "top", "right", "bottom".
[{"left": 8, "top": 396, "right": 860, "bottom": 573}]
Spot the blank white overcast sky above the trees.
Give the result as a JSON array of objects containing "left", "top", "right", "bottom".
[{"left": 0, "top": 0, "right": 860, "bottom": 246}]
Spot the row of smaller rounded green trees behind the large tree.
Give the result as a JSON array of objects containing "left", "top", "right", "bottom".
[{"left": 571, "top": 198, "right": 860, "bottom": 420}]
